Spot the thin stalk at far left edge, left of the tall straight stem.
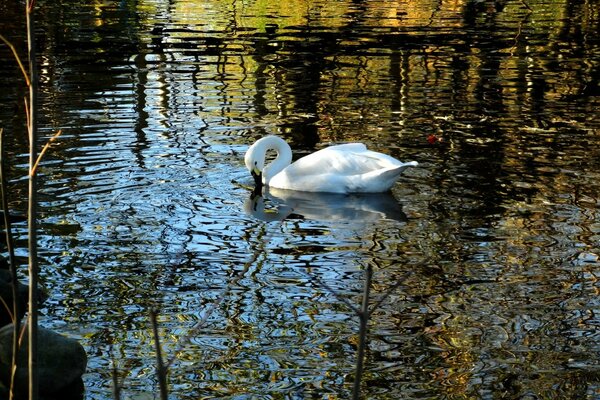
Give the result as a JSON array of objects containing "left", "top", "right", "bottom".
[{"left": 0, "top": 129, "right": 21, "bottom": 400}]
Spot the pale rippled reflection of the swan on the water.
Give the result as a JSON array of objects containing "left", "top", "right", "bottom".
[{"left": 244, "top": 188, "right": 407, "bottom": 221}]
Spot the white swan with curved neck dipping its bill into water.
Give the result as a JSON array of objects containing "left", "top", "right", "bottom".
[{"left": 244, "top": 136, "right": 417, "bottom": 193}]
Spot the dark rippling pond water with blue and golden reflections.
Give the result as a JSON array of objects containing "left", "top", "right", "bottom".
[{"left": 0, "top": 0, "right": 600, "bottom": 399}]
